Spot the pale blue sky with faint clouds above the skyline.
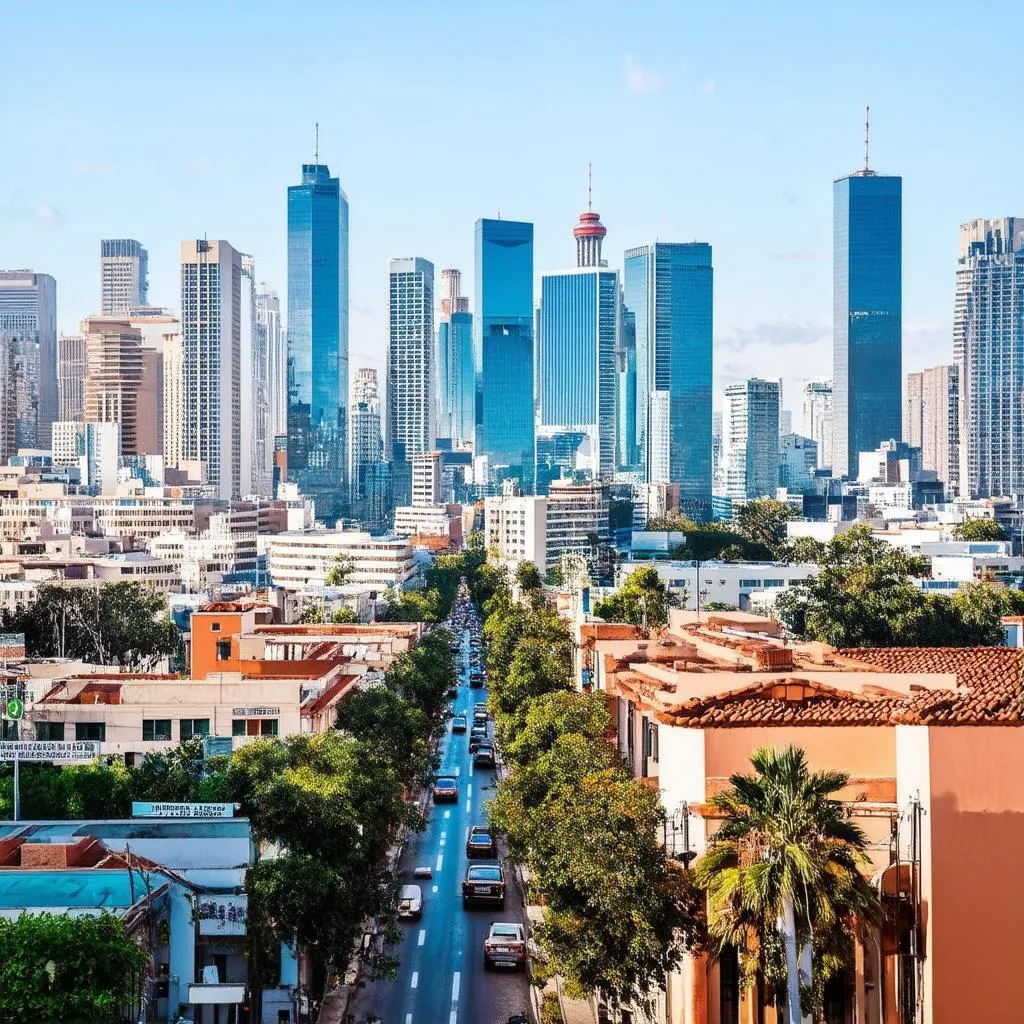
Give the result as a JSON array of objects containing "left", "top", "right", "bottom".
[{"left": 0, "top": 0, "right": 1024, "bottom": 404}]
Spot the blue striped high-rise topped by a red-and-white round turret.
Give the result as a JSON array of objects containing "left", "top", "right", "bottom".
[{"left": 536, "top": 204, "right": 622, "bottom": 481}]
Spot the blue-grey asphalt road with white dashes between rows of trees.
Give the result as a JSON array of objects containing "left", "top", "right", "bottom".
[{"left": 353, "top": 614, "right": 529, "bottom": 1024}]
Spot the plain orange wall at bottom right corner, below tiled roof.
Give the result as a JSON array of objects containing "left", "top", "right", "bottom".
[{"left": 925, "top": 726, "right": 1024, "bottom": 1024}]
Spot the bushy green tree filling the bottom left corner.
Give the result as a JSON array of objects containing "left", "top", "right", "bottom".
[{"left": 0, "top": 913, "right": 148, "bottom": 1024}]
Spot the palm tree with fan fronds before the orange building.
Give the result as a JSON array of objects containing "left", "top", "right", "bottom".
[{"left": 696, "top": 746, "right": 881, "bottom": 1024}]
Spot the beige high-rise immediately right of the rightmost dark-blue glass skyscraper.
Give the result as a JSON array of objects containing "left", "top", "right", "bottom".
[{"left": 903, "top": 366, "right": 959, "bottom": 493}]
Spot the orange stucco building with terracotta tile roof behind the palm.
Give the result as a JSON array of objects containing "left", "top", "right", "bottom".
[{"left": 580, "top": 611, "right": 1024, "bottom": 1024}]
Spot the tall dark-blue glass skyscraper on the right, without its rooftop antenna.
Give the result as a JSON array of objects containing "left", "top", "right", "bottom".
[{"left": 831, "top": 167, "right": 903, "bottom": 477}]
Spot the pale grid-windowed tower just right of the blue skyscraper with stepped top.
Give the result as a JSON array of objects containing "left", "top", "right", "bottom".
[{"left": 384, "top": 256, "right": 436, "bottom": 459}]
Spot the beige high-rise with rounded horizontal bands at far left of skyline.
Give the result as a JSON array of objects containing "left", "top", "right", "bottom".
[{"left": 82, "top": 316, "right": 142, "bottom": 455}]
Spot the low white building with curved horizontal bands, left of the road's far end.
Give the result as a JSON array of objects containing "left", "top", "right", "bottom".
[{"left": 263, "top": 530, "right": 416, "bottom": 590}]
